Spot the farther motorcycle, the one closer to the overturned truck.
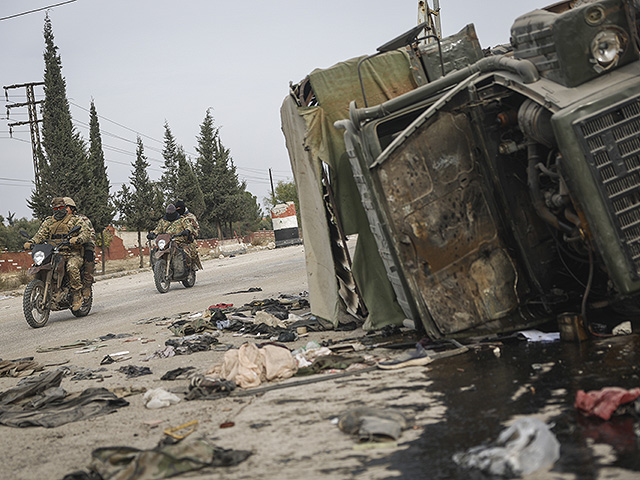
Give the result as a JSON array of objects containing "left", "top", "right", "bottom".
[{"left": 151, "top": 230, "right": 196, "bottom": 293}]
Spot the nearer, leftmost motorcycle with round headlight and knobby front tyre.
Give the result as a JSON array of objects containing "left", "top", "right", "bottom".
[{"left": 20, "top": 225, "right": 93, "bottom": 328}]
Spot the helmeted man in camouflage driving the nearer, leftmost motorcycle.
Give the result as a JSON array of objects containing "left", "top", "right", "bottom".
[{"left": 24, "top": 197, "right": 91, "bottom": 310}]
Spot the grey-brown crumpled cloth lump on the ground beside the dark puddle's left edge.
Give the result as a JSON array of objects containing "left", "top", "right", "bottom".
[{"left": 338, "top": 407, "right": 409, "bottom": 442}]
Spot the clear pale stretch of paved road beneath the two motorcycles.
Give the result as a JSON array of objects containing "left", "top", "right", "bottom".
[{"left": 0, "top": 246, "right": 307, "bottom": 359}]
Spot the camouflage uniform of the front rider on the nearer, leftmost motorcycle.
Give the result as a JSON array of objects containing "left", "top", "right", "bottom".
[{"left": 29, "top": 209, "right": 91, "bottom": 291}]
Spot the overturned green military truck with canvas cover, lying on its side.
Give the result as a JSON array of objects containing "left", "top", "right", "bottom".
[{"left": 281, "top": 0, "right": 640, "bottom": 339}]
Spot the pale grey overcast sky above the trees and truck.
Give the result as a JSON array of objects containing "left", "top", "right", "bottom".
[{"left": 0, "top": 0, "right": 552, "bottom": 218}]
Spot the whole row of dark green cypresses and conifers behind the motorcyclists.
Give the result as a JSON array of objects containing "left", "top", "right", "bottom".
[{"left": 28, "top": 16, "right": 263, "bottom": 249}]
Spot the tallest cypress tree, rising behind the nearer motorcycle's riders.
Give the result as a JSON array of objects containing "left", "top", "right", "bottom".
[{"left": 28, "top": 15, "right": 92, "bottom": 219}]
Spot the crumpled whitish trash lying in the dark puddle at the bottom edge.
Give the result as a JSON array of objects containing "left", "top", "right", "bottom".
[{"left": 453, "top": 417, "right": 560, "bottom": 477}]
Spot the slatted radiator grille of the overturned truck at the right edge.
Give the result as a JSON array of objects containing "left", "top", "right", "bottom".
[{"left": 576, "top": 97, "right": 640, "bottom": 276}]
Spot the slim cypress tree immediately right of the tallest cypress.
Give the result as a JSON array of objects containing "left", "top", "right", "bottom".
[{"left": 84, "top": 100, "right": 114, "bottom": 273}]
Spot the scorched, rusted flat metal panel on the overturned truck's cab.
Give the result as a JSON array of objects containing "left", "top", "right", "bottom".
[{"left": 372, "top": 113, "right": 518, "bottom": 334}]
